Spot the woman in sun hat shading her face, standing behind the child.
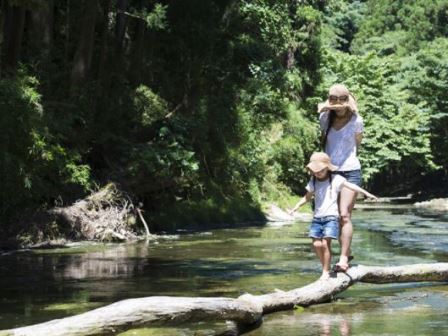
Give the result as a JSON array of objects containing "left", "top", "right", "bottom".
[{"left": 318, "top": 84, "right": 364, "bottom": 272}]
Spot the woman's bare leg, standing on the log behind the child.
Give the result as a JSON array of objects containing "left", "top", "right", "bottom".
[{"left": 338, "top": 188, "right": 356, "bottom": 268}]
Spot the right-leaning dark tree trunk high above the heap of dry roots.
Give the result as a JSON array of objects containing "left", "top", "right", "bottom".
[{"left": 70, "top": 0, "right": 98, "bottom": 94}]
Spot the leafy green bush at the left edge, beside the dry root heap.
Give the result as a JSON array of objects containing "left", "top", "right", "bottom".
[{"left": 0, "top": 73, "right": 91, "bottom": 218}]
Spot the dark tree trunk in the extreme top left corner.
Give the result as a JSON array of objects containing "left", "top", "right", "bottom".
[{"left": 0, "top": 1, "right": 26, "bottom": 75}]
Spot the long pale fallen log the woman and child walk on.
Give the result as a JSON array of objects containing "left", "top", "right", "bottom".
[{"left": 0, "top": 263, "right": 448, "bottom": 336}]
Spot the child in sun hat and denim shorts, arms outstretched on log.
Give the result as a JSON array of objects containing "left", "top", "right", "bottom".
[{"left": 288, "top": 152, "right": 377, "bottom": 280}]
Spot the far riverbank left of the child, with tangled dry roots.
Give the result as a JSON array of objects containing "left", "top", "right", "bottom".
[{"left": 0, "top": 191, "right": 294, "bottom": 251}]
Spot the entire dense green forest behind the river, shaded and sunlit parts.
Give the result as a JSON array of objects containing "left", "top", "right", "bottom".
[{"left": 0, "top": 0, "right": 448, "bottom": 240}]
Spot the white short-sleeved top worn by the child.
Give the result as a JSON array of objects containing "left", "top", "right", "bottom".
[{"left": 306, "top": 174, "right": 347, "bottom": 218}]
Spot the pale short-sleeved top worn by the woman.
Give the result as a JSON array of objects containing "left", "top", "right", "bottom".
[{"left": 319, "top": 112, "right": 364, "bottom": 171}]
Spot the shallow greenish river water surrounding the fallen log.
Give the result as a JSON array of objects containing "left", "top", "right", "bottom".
[{"left": 0, "top": 209, "right": 448, "bottom": 336}]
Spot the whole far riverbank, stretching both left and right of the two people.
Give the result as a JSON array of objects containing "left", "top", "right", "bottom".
[{"left": 0, "top": 188, "right": 448, "bottom": 251}]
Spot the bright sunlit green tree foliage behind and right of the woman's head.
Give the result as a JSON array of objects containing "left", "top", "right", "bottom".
[{"left": 318, "top": 0, "right": 448, "bottom": 192}]
